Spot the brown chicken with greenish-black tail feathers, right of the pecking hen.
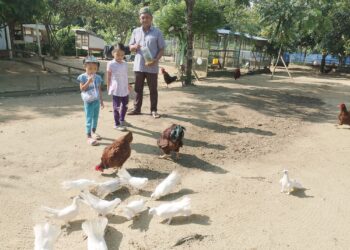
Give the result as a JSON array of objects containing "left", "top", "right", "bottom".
[{"left": 157, "top": 124, "right": 186, "bottom": 159}]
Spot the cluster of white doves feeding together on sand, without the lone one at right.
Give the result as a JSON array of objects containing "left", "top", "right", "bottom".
[{"left": 34, "top": 169, "right": 191, "bottom": 250}]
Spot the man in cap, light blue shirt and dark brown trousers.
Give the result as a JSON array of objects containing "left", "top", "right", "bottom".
[{"left": 128, "top": 7, "right": 165, "bottom": 118}]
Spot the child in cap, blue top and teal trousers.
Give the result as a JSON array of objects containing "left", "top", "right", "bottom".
[{"left": 78, "top": 56, "right": 104, "bottom": 146}]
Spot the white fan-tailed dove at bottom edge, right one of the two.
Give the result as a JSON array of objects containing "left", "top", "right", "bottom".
[{"left": 81, "top": 217, "right": 108, "bottom": 250}]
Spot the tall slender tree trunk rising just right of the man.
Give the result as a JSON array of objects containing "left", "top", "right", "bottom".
[{"left": 185, "top": 0, "right": 195, "bottom": 85}]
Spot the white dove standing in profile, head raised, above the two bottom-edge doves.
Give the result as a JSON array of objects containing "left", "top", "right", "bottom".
[{"left": 41, "top": 196, "right": 81, "bottom": 227}]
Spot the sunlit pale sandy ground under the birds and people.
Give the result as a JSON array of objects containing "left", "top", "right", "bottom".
[{"left": 0, "top": 65, "right": 350, "bottom": 249}]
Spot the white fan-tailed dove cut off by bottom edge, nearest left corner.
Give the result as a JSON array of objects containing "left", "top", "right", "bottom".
[{"left": 33, "top": 222, "right": 61, "bottom": 250}]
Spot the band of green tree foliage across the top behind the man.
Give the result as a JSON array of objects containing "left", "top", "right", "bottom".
[{"left": 0, "top": 0, "right": 350, "bottom": 59}]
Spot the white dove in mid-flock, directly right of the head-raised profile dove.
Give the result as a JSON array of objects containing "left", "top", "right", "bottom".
[{"left": 80, "top": 192, "right": 121, "bottom": 216}]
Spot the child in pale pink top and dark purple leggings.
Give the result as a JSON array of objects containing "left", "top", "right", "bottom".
[{"left": 107, "top": 43, "right": 129, "bottom": 131}]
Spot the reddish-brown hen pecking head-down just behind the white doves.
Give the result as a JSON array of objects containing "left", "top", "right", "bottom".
[{"left": 95, "top": 132, "right": 133, "bottom": 172}]
